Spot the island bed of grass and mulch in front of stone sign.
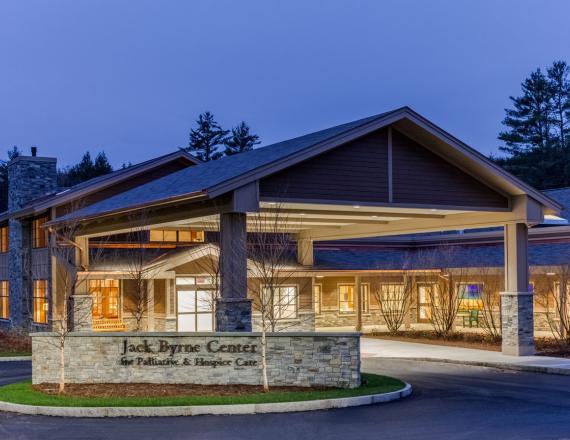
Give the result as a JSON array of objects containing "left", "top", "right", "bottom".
[{"left": 0, "top": 373, "right": 405, "bottom": 407}]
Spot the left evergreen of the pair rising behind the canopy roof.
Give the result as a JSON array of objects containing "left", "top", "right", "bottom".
[{"left": 185, "top": 111, "right": 229, "bottom": 162}]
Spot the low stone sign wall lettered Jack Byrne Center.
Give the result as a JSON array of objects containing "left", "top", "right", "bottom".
[{"left": 32, "top": 332, "right": 360, "bottom": 388}]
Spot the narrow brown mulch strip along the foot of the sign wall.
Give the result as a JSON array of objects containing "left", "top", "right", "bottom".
[{"left": 33, "top": 383, "right": 330, "bottom": 397}]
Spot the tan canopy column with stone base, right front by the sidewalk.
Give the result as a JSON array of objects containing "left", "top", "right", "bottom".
[{"left": 501, "top": 223, "right": 534, "bottom": 356}]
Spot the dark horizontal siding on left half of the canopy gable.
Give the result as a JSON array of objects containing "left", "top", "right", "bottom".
[{"left": 260, "top": 130, "right": 388, "bottom": 202}]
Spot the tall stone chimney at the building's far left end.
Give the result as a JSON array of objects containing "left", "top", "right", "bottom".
[{"left": 8, "top": 149, "right": 57, "bottom": 330}]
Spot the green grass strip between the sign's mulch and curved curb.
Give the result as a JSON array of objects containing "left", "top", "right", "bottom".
[{"left": 0, "top": 373, "right": 404, "bottom": 407}]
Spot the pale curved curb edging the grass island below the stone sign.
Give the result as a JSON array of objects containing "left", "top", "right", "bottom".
[{"left": 0, "top": 383, "right": 412, "bottom": 417}]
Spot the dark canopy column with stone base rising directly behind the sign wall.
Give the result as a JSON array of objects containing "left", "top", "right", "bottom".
[{"left": 216, "top": 212, "right": 251, "bottom": 332}]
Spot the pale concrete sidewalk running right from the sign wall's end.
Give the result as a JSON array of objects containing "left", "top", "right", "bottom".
[{"left": 360, "top": 337, "right": 570, "bottom": 375}]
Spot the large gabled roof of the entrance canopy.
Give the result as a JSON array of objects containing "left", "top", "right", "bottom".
[{"left": 55, "top": 107, "right": 562, "bottom": 221}]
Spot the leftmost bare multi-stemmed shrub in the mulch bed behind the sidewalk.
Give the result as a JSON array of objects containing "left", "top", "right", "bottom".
[{"left": 370, "top": 271, "right": 414, "bottom": 334}]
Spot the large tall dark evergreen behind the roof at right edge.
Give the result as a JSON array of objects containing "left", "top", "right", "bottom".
[{"left": 492, "top": 61, "right": 570, "bottom": 189}]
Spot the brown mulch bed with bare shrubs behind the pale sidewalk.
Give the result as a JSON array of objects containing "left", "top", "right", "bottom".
[{"left": 366, "top": 330, "right": 570, "bottom": 358}]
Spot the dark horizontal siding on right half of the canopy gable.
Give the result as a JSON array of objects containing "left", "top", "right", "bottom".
[{"left": 392, "top": 130, "right": 508, "bottom": 208}]
